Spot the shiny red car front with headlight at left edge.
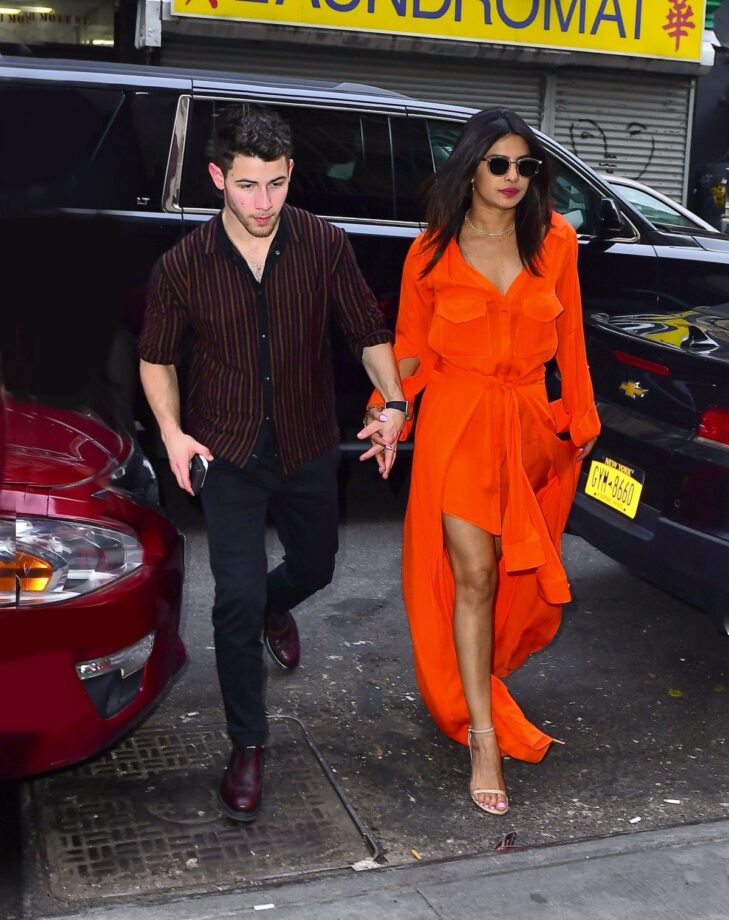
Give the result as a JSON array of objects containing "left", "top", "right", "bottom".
[{"left": 0, "top": 400, "right": 185, "bottom": 777}]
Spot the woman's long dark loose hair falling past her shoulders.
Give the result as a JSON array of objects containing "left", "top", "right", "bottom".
[{"left": 421, "top": 109, "right": 552, "bottom": 277}]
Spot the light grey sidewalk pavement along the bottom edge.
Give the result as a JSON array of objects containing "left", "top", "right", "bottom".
[{"left": 45, "top": 818, "right": 729, "bottom": 920}]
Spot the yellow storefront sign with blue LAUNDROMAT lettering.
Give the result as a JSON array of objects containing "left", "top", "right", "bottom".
[{"left": 172, "top": 0, "right": 706, "bottom": 61}]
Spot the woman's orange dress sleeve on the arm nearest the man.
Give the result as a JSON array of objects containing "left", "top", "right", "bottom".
[{"left": 370, "top": 236, "right": 436, "bottom": 441}]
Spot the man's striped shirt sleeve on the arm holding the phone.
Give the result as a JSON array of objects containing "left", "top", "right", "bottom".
[{"left": 139, "top": 260, "right": 188, "bottom": 364}]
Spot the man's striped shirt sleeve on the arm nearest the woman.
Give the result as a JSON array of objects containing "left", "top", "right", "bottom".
[{"left": 331, "top": 233, "right": 393, "bottom": 360}]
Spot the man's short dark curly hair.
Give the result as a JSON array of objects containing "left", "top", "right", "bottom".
[{"left": 210, "top": 105, "right": 294, "bottom": 173}]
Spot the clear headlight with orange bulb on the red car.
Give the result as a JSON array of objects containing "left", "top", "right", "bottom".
[{"left": 7, "top": 517, "right": 143, "bottom": 606}]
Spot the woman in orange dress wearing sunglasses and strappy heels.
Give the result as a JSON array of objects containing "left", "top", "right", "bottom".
[{"left": 360, "top": 109, "right": 600, "bottom": 814}]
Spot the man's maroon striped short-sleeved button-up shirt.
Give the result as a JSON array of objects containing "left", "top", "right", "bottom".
[{"left": 139, "top": 205, "right": 392, "bottom": 472}]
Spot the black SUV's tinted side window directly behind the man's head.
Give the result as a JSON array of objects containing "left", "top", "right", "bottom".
[{"left": 180, "top": 99, "right": 394, "bottom": 220}]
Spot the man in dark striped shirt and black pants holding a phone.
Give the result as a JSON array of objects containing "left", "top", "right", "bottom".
[{"left": 140, "top": 106, "right": 407, "bottom": 821}]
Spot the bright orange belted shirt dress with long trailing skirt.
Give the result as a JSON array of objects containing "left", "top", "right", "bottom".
[{"left": 382, "top": 213, "right": 600, "bottom": 762}]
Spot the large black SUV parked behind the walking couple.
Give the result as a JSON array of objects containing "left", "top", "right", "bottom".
[{"left": 0, "top": 57, "right": 729, "bottom": 447}]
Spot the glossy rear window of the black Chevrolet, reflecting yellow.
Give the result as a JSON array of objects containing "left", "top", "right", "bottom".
[{"left": 586, "top": 304, "right": 729, "bottom": 364}]
